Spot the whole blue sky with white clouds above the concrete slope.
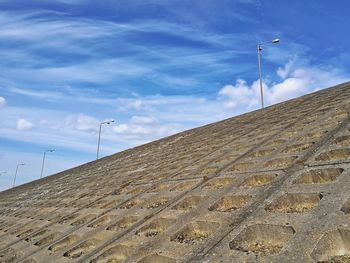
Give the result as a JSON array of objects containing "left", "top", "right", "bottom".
[{"left": 0, "top": 0, "right": 350, "bottom": 190}]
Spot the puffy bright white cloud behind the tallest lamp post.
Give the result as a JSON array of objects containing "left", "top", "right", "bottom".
[{"left": 218, "top": 60, "right": 349, "bottom": 111}]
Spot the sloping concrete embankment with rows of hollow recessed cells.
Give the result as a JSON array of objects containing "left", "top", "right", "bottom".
[{"left": 0, "top": 83, "right": 350, "bottom": 263}]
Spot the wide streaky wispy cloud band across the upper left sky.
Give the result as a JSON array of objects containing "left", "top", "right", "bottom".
[{"left": 0, "top": 8, "right": 258, "bottom": 89}]
